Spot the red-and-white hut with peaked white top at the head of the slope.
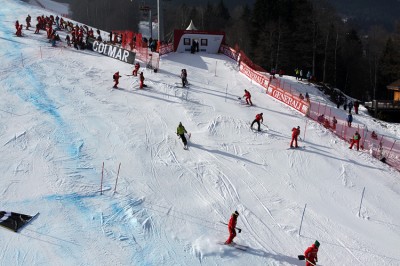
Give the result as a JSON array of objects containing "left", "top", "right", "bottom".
[{"left": 174, "top": 21, "right": 225, "bottom": 54}]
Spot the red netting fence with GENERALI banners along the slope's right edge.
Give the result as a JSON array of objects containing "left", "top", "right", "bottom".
[{"left": 220, "top": 45, "right": 400, "bottom": 171}]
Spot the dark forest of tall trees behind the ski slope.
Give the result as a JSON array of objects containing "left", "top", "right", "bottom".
[{"left": 70, "top": 0, "right": 400, "bottom": 101}]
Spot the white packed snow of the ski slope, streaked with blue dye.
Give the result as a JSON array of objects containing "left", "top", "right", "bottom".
[{"left": 0, "top": 0, "right": 400, "bottom": 266}]
